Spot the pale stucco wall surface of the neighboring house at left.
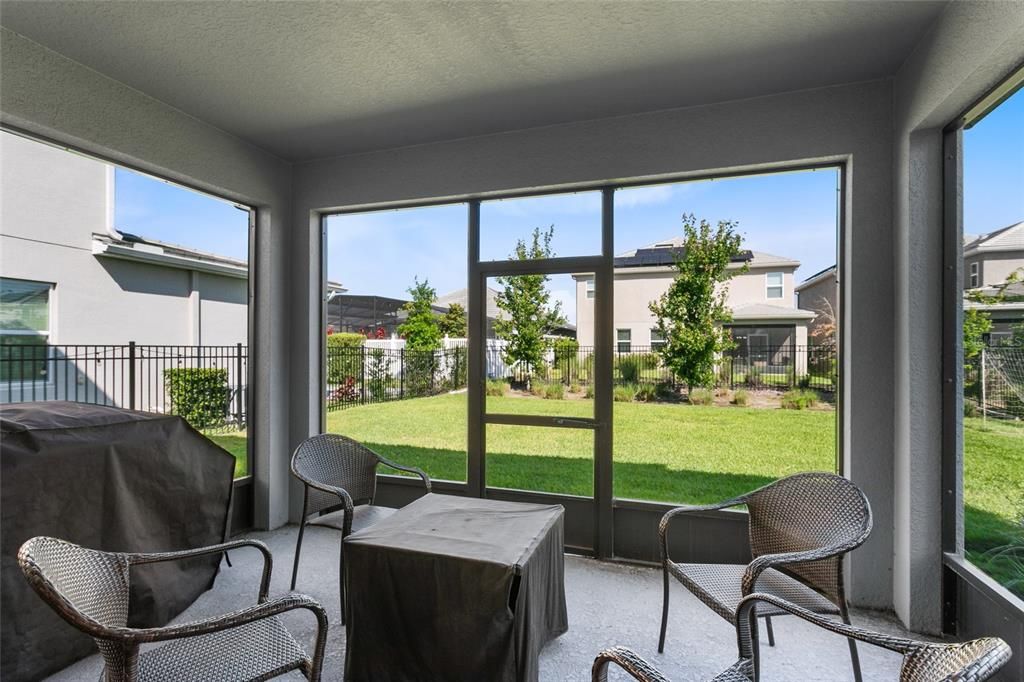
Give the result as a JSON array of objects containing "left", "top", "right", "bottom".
[{"left": 0, "top": 133, "right": 248, "bottom": 345}]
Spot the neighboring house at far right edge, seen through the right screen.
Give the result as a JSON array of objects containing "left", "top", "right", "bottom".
[{"left": 964, "top": 221, "right": 1024, "bottom": 343}]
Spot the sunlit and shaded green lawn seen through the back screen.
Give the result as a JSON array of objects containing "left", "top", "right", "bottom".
[{"left": 328, "top": 387, "right": 836, "bottom": 503}]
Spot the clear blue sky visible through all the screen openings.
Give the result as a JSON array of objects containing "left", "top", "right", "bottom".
[{"left": 115, "top": 84, "right": 1024, "bottom": 318}]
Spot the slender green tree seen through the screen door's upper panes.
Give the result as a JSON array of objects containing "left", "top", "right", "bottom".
[{"left": 495, "top": 225, "right": 565, "bottom": 371}]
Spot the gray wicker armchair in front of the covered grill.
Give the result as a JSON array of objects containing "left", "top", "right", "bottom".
[{"left": 17, "top": 537, "right": 328, "bottom": 682}]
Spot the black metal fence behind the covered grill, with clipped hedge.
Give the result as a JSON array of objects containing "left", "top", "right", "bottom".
[{"left": 0, "top": 342, "right": 248, "bottom": 429}]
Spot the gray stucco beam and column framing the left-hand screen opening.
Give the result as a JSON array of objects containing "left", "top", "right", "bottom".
[{"left": 0, "top": 29, "right": 291, "bottom": 526}]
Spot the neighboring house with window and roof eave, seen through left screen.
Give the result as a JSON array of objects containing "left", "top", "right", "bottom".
[{"left": 0, "top": 133, "right": 268, "bottom": 345}]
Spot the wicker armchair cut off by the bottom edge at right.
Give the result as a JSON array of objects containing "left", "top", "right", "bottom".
[{"left": 591, "top": 593, "right": 1011, "bottom": 682}]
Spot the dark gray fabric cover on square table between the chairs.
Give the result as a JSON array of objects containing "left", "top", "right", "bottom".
[{"left": 345, "top": 495, "right": 568, "bottom": 682}]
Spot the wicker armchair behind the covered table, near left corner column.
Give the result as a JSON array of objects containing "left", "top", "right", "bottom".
[{"left": 292, "top": 433, "right": 430, "bottom": 625}]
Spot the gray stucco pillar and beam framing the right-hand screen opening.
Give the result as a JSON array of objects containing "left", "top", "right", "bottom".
[{"left": 892, "top": 2, "right": 1024, "bottom": 631}]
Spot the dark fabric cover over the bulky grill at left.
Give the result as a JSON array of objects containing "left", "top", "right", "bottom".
[{"left": 0, "top": 401, "right": 234, "bottom": 682}]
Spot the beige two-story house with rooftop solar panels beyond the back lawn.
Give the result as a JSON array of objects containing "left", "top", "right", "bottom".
[{"left": 572, "top": 238, "right": 814, "bottom": 352}]
